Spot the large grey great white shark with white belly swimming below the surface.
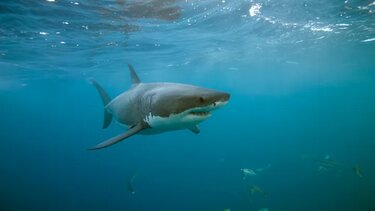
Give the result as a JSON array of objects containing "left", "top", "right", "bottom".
[{"left": 89, "top": 64, "right": 230, "bottom": 150}]
